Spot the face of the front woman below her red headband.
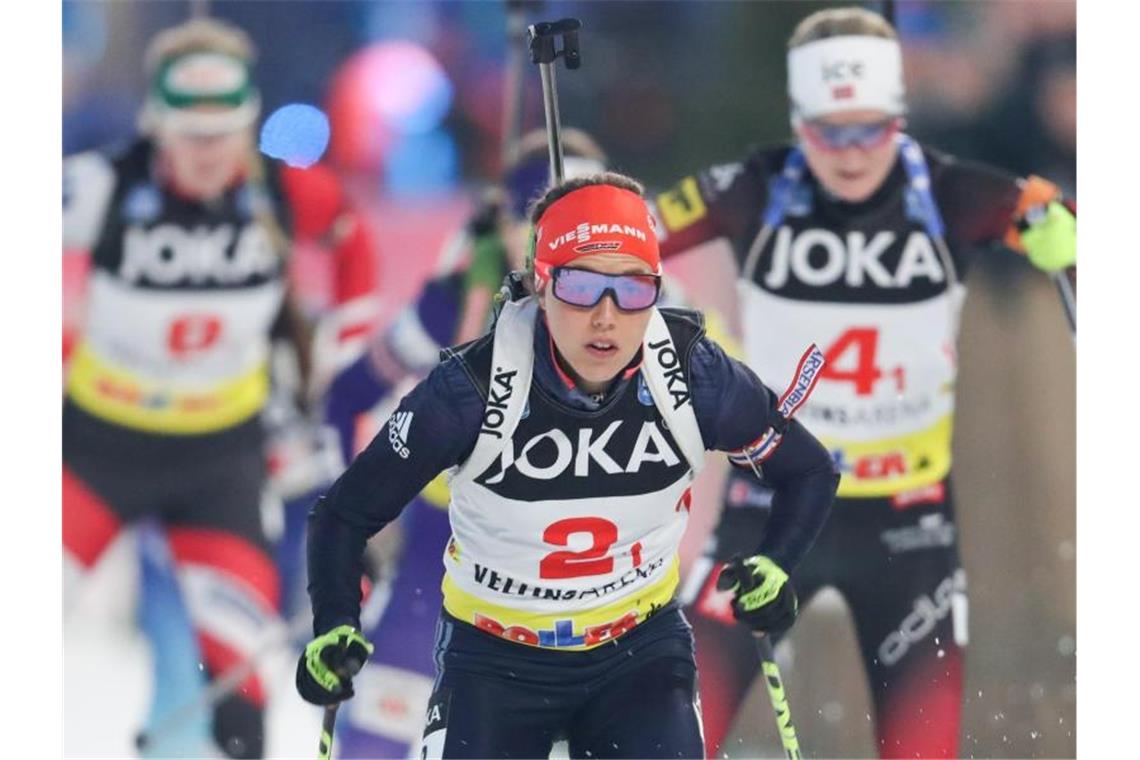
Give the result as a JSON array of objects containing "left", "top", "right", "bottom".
[{"left": 538, "top": 254, "right": 652, "bottom": 393}]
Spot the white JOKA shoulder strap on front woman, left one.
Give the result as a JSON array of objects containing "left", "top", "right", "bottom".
[{"left": 451, "top": 296, "right": 538, "bottom": 487}]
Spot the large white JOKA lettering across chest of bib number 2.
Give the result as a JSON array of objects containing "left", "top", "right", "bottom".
[{"left": 481, "top": 419, "right": 681, "bottom": 485}]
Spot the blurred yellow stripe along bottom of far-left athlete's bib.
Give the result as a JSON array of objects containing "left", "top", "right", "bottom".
[{"left": 67, "top": 343, "right": 269, "bottom": 435}]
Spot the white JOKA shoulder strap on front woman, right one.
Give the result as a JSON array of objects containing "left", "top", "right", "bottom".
[{"left": 641, "top": 308, "right": 705, "bottom": 476}]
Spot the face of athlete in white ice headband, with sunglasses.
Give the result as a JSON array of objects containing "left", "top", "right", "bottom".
[{"left": 796, "top": 111, "right": 902, "bottom": 203}]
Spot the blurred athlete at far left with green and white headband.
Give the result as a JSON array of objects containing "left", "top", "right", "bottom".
[{"left": 63, "top": 19, "right": 376, "bottom": 758}]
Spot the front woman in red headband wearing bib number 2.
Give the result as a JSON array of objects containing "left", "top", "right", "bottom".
[{"left": 296, "top": 173, "right": 837, "bottom": 758}]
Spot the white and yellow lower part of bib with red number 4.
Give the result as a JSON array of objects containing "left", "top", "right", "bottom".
[{"left": 739, "top": 272, "right": 964, "bottom": 498}]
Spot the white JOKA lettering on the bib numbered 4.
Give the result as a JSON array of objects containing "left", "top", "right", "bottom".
[{"left": 764, "top": 227, "right": 946, "bottom": 289}]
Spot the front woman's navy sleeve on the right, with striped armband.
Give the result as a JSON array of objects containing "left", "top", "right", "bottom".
[{"left": 691, "top": 338, "right": 839, "bottom": 572}]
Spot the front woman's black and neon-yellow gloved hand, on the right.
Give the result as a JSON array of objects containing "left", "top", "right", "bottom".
[{"left": 716, "top": 554, "right": 799, "bottom": 634}]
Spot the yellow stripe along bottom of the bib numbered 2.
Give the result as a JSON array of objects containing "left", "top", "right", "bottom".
[{"left": 441, "top": 556, "right": 681, "bottom": 651}]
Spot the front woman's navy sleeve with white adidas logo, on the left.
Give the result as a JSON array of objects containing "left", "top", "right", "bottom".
[{"left": 308, "top": 359, "right": 483, "bottom": 635}]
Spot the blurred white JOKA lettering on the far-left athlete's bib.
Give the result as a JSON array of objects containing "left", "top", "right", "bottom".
[{"left": 119, "top": 224, "right": 280, "bottom": 285}]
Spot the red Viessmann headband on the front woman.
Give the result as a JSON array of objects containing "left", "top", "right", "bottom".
[{"left": 535, "top": 185, "right": 661, "bottom": 273}]
